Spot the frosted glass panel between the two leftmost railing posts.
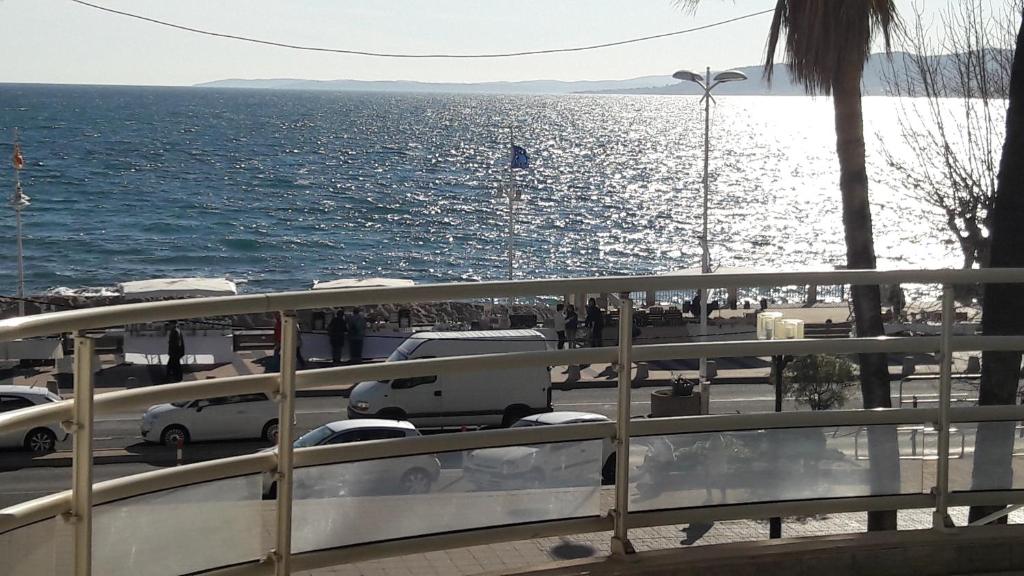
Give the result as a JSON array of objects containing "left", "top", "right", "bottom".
[{"left": 92, "top": 476, "right": 266, "bottom": 576}]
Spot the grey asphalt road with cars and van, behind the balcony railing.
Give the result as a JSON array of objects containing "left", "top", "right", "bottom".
[{"left": 0, "top": 380, "right": 976, "bottom": 508}]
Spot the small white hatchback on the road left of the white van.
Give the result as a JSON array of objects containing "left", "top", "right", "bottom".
[{"left": 141, "top": 393, "right": 278, "bottom": 446}]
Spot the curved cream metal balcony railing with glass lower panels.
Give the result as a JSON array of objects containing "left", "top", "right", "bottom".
[{"left": 0, "top": 270, "right": 1024, "bottom": 576}]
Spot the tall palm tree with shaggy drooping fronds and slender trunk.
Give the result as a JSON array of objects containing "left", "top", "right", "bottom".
[{"left": 682, "top": 0, "right": 900, "bottom": 530}]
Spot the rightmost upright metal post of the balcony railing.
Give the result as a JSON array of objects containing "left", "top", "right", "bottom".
[{"left": 932, "top": 284, "right": 954, "bottom": 529}]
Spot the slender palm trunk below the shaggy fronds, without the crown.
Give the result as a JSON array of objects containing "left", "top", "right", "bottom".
[{"left": 833, "top": 62, "right": 900, "bottom": 530}]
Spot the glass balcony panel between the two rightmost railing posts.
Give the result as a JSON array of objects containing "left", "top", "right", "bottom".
[{"left": 630, "top": 426, "right": 934, "bottom": 510}]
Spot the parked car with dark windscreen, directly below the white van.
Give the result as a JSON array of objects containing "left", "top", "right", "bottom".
[{"left": 263, "top": 418, "right": 441, "bottom": 498}]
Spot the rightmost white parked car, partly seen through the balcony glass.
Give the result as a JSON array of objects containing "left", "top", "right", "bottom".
[{"left": 463, "top": 412, "right": 615, "bottom": 489}]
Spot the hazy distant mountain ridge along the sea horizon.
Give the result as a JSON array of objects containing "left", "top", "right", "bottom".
[{"left": 196, "top": 52, "right": 999, "bottom": 95}]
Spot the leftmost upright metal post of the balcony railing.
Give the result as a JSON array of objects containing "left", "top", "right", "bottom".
[{"left": 70, "top": 331, "right": 96, "bottom": 576}]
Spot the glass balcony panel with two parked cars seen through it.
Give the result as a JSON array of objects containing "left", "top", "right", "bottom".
[{"left": 292, "top": 440, "right": 610, "bottom": 552}]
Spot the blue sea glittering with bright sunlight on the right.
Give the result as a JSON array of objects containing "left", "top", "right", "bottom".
[{"left": 0, "top": 85, "right": 961, "bottom": 294}]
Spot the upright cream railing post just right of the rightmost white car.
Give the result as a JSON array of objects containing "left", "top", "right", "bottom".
[{"left": 611, "top": 292, "right": 635, "bottom": 556}]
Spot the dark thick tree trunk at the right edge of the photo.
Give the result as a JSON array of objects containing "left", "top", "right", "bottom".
[{"left": 969, "top": 13, "right": 1024, "bottom": 522}]
